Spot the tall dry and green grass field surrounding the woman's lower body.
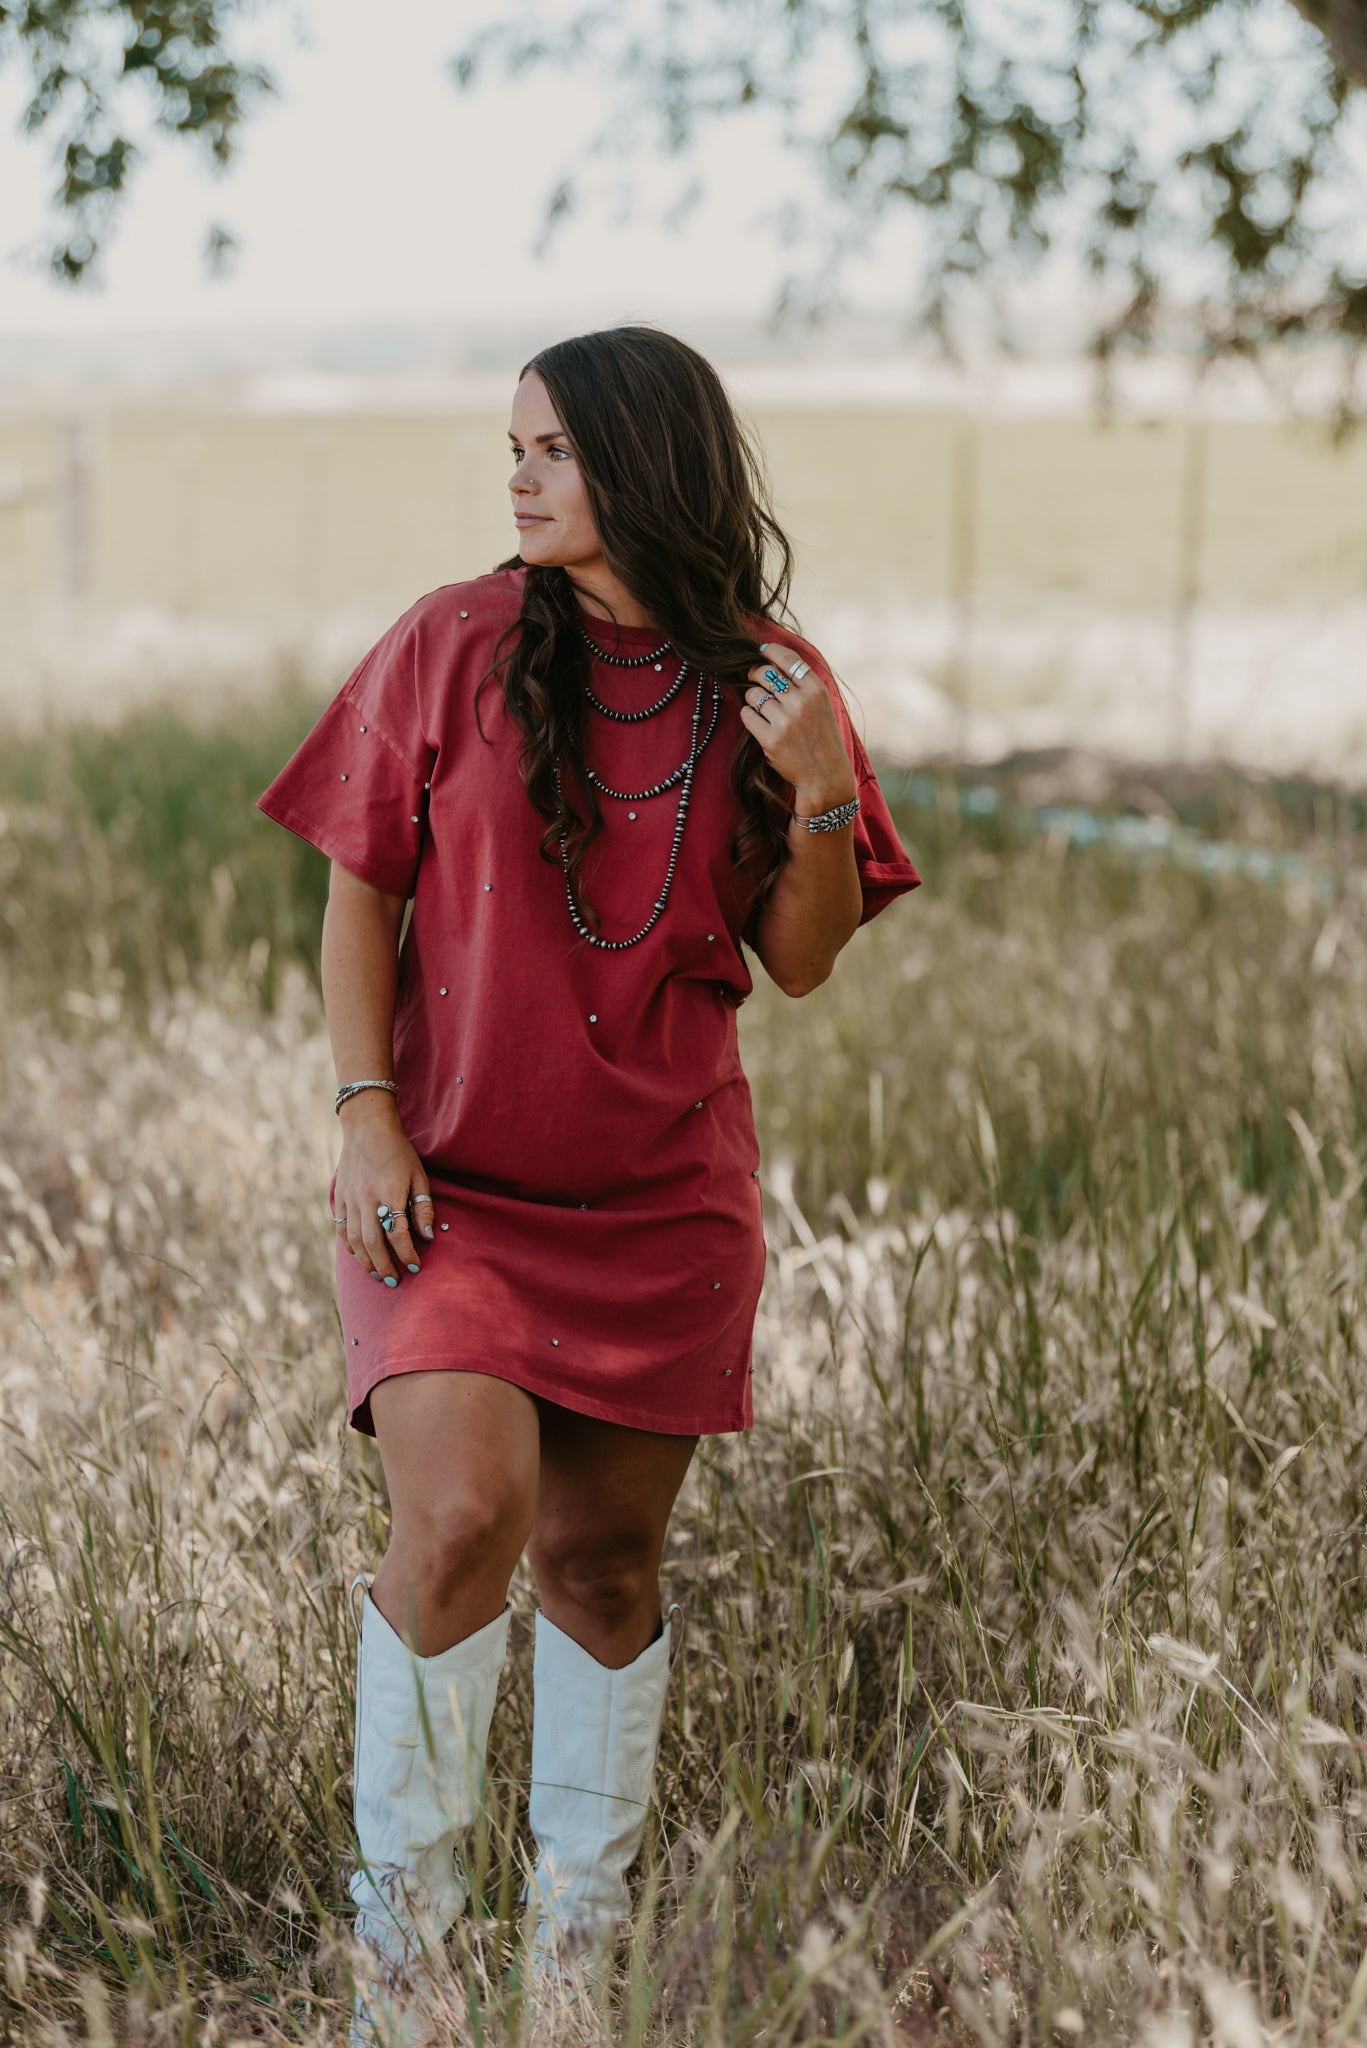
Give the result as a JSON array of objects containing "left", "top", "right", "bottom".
[{"left": 0, "top": 702, "right": 1367, "bottom": 2048}]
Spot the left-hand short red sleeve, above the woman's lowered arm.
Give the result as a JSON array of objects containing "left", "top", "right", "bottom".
[{"left": 256, "top": 614, "right": 437, "bottom": 897}]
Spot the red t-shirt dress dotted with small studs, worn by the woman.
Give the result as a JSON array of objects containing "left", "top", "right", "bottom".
[{"left": 256, "top": 569, "right": 920, "bottom": 1436}]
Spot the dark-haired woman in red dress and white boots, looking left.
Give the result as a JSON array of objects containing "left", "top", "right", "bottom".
[{"left": 258, "top": 328, "right": 918, "bottom": 2038}]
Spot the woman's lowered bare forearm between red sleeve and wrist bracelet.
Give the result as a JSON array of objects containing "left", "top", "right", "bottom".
[{"left": 320, "top": 862, "right": 404, "bottom": 1120}]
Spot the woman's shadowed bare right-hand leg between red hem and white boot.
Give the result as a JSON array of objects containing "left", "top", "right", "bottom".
[{"left": 527, "top": 1401, "right": 697, "bottom": 1669}]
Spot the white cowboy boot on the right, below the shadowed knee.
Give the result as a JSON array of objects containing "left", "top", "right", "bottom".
[{"left": 523, "top": 1606, "right": 682, "bottom": 1991}]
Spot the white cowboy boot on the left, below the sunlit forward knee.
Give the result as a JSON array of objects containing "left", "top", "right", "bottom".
[{"left": 350, "top": 1579, "right": 510, "bottom": 2048}]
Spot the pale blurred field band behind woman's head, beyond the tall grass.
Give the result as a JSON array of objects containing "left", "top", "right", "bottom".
[{"left": 0, "top": 360, "right": 1367, "bottom": 776}]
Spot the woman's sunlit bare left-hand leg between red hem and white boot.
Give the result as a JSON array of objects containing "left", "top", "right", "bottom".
[{"left": 371, "top": 1372, "right": 541, "bottom": 1657}]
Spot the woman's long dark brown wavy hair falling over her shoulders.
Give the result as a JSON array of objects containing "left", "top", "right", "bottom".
[{"left": 475, "top": 326, "right": 797, "bottom": 932}]
